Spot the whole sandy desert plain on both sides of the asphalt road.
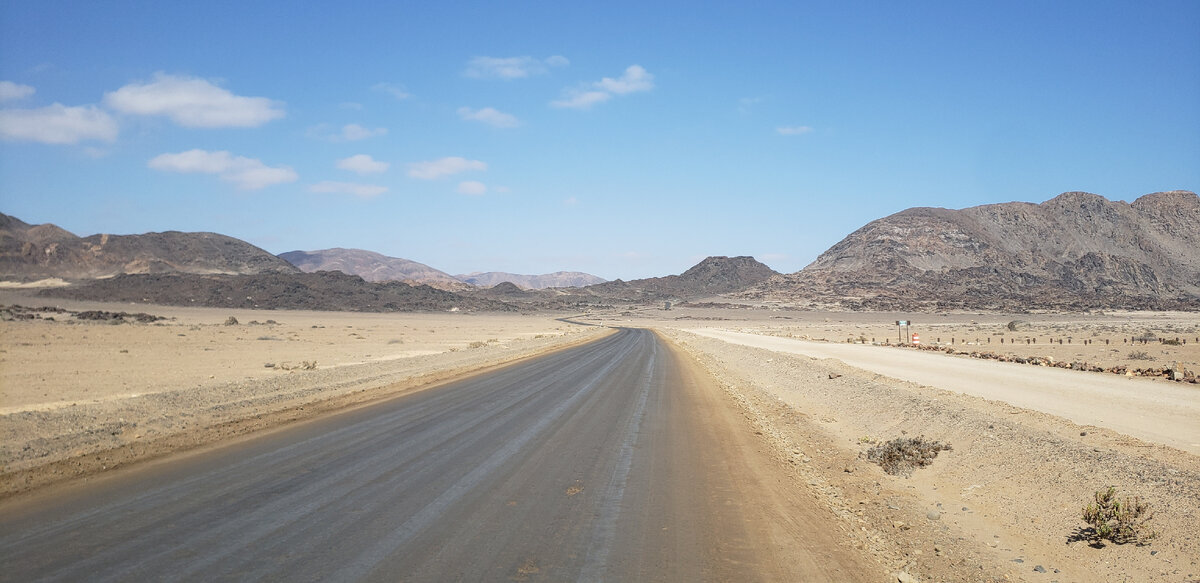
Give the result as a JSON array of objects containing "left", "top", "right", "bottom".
[{"left": 0, "top": 290, "right": 1200, "bottom": 582}]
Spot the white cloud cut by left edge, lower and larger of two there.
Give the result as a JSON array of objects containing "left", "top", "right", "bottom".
[{"left": 0, "top": 103, "right": 119, "bottom": 144}]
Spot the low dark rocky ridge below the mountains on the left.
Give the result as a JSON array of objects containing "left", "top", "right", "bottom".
[{"left": 38, "top": 271, "right": 516, "bottom": 312}]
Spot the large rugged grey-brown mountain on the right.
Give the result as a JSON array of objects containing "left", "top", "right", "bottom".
[{"left": 744, "top": 191, "right": 1200, "bottom": 309}]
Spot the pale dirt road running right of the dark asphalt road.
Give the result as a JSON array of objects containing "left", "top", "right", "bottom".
[{"left": 692, "top": 329, "right": 1200, "bottom": 453}]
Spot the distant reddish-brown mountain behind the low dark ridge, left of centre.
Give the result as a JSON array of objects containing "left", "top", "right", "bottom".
[{"left": 280, "top": 247, "right": 470, "bottom": 290}]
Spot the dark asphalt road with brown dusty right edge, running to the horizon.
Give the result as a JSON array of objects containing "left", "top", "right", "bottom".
[{"left": 0, "top": 330, "right": 878, "bottom": 582}]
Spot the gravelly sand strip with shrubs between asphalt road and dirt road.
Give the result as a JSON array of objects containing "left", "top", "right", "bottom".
[{"left": 655, "top": 326, "right": 1200, "bottom": 583}]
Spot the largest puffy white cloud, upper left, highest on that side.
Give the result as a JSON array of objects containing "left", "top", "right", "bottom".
[{"left": 104, "top": 72, "right": 284, "bottom": 127}]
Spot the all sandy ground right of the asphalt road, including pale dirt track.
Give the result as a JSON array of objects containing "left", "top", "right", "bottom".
[{"left": 592, "top": 308, "right": 1200, "bottom": 582}]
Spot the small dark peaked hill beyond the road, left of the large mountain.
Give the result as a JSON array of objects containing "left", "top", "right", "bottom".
[{"left": 583, "top": 256, "right": 779, "bottom": 300}]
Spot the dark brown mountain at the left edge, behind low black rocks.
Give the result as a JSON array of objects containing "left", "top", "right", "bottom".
[{"left": 0, "top": 214, "right": 296, "bottom": 281}]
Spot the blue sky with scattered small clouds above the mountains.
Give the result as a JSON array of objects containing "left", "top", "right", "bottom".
[{"left": 0, "top": 0, "right": 1200, "bottom": 280}]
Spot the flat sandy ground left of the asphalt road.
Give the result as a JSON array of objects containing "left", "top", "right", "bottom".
[{"left": 0, "top": 296, "right": 606, "bottom": 494}]
